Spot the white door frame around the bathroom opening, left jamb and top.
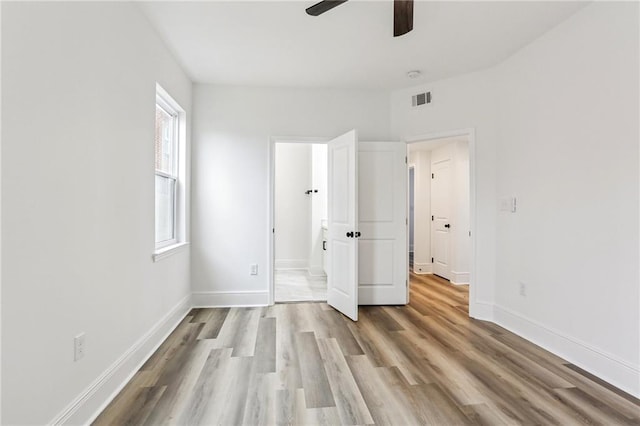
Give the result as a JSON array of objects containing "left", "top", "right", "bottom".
[{"left": 266, "top": 136, "right": 331, "bottom": 306}]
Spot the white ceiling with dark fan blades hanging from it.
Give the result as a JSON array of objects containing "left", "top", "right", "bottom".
[{"left": 140, "top": 0, "right": 585, "bottom": 89}]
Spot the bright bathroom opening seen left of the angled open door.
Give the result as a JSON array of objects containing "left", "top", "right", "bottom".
[{"left": 273, "top": 142, "right": 327, "bottom": 302}]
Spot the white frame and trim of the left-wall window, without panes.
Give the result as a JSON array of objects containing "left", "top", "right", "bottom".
[{"left": 153, "top": 84, "right": 188, "bottom": 262}]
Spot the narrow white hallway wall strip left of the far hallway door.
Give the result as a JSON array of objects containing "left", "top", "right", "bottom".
[{"left": 409, "top": 151, "right": 433, "bottom": 274}]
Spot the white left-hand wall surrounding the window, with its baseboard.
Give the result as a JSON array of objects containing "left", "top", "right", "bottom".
[{"left": 2, "top": 2, "right": 191, "bottom": 424}]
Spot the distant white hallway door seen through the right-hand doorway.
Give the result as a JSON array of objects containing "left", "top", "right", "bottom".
[{"left": 431, "top": 151, "right": 452, "bottom": 279}]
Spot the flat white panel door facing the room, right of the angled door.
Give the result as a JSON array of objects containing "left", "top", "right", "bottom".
[{"left": 358, "top": 142, "right": 408, "bottom": 305}]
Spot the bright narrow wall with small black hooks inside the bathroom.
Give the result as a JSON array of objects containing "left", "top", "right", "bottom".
[{"left": 309, "top": 144, "right": 329, "bottom": 275}]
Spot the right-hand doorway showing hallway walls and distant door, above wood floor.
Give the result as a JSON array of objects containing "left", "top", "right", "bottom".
[{"left": 407, "top": 130, "right": 475, "bottom": 312}]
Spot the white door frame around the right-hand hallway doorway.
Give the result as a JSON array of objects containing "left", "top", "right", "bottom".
[{"left": 406, "top": 127, "right": 478, "bottom": 318}]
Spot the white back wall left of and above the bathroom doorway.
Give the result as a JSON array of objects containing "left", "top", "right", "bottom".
[{"left": 192, "top": 85, "right": 390, "bottom": 305}]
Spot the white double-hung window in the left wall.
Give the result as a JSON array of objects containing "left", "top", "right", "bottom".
[{"left": 155, "top": 86, "right": 185, "bottom": 252}]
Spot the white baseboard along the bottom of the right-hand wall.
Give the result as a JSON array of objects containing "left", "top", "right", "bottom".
[{"left": 494, "top": 305, "right": 640, "bottom": 398}]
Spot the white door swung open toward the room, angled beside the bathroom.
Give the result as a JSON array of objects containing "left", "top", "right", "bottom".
[{"left": 327, "top": 130, "right": 358, "bottom": 321}]
